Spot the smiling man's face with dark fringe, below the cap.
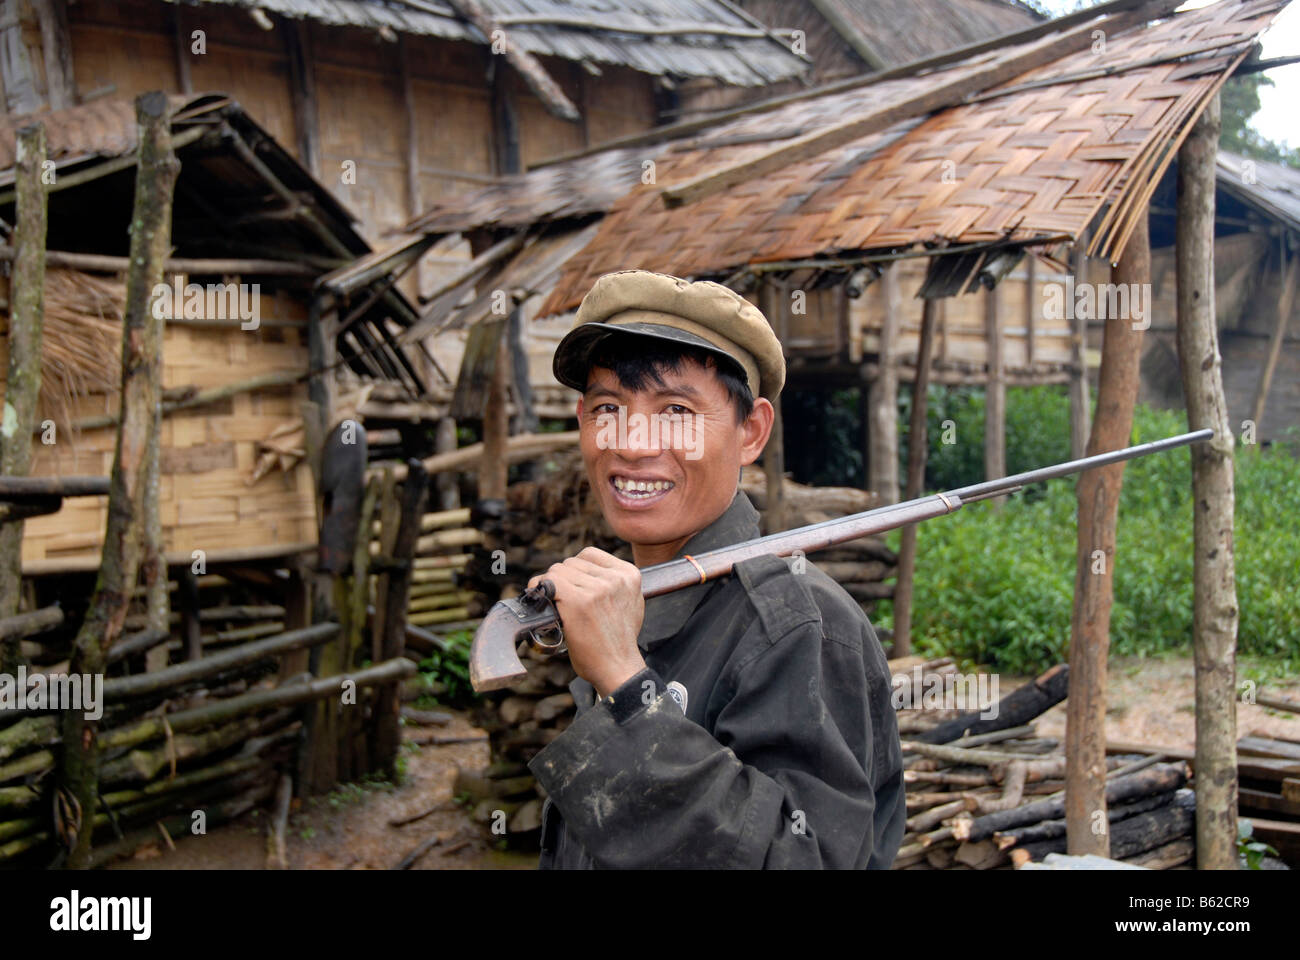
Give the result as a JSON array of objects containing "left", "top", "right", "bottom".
[{"left": 577, "top": 359, "right": 772, "bottom": 556}]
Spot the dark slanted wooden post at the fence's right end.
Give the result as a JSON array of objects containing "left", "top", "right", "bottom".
[{"left": 371, "top": 459, "right": 429, "bottom": 778}]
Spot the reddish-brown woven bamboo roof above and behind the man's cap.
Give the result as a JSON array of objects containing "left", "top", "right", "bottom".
[{"left": 542, "top": 0, "right": 1286, "bottom": 313}]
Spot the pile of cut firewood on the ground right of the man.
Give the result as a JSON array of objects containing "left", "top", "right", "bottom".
[{"left": 894, "top": 661, "right": 1195, "bottom": 870}]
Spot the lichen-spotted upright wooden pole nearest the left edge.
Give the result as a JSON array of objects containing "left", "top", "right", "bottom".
[{"left": 0, "top": 124, "right": 47, "bottom": 674}]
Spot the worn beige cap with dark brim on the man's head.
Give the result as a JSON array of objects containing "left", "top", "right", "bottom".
[{"left": 553, "top": 271, "right": 785, "bottom": 401}]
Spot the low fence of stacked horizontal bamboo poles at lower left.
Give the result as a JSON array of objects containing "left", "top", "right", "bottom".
[{"left": 0, "top": 575, "right": 413, "bottom": 866}]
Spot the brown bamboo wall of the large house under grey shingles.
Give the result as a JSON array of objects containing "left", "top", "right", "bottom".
[{"left": 62, "top": 0, "right": 655, "bottom": 247}]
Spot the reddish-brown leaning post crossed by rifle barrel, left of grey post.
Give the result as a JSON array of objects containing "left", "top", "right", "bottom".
[{"left": 1066, "top": 213, "right": 1151, "bottom": 857}]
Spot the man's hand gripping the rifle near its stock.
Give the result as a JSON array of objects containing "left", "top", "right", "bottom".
[{"left": 528, "top": 546, "right": 646, "bottom": 697}]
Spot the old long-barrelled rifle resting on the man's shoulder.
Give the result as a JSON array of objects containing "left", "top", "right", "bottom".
[{"left": 469, "top": 429, "right": 1214, "bottom": 693}]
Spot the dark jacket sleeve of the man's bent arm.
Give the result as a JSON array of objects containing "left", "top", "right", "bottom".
[{"left": 529, "top": 613, "right": 875, "bottom": 869}]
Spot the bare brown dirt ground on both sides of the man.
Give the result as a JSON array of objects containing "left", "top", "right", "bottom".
[{"left": 108, "top": 657, "right": 1300, "bottom": 870}]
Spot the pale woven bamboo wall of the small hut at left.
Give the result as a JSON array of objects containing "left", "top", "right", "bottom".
[{"left": 0, "top": 287, "right": 316, "bottom": 564}]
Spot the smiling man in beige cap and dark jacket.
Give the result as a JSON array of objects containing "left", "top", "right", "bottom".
[{"left": 529, "top": 271, "right": 906, "bottom": 869}]
